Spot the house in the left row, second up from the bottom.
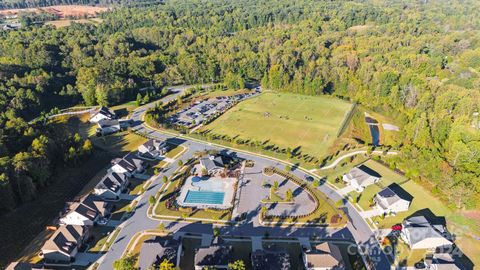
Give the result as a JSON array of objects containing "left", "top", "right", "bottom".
[{"left": 60, "top": 194, "right": 109, "bottom": 226}]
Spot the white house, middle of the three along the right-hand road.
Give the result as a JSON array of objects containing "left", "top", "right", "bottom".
[{"left": 373, "top": 187, "right": 412, "bottom": 214}]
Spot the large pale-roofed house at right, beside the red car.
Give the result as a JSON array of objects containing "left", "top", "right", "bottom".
[{"left": 401, "top": 216, "right": 453, "bottom": 250}]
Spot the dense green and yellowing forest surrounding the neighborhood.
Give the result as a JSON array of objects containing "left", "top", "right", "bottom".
[{"left": 0, "top": 0, "right": 480, "bottom": 209}]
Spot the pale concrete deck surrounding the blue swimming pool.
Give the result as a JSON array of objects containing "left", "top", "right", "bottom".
[{"left": 177, "top": 176, "right": 237, "bottom": 209}]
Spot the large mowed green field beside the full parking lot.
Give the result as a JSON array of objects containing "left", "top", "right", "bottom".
[{"left": 202, "top": 93, "right": 352, "bottom": 157}]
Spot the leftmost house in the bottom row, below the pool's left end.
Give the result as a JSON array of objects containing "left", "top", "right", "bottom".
[{"left": 138, "top": 237, "right": 181, "bottom": 270}]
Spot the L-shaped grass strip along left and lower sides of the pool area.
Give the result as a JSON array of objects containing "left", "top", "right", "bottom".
[{"left": 148, "top": 160, "right": 232, "bottom": 223}]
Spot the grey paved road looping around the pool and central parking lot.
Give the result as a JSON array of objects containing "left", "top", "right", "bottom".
[{"left": 98, "top": 87, "right": 390, "bottom": 270}]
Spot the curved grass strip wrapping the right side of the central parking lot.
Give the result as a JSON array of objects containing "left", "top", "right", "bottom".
[{"left": 260, "top": 167, "right": 347, "bottom": 227}]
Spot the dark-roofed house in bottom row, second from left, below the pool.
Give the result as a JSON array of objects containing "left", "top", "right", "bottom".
[{"left": 195, "top": 245, "right": 234, "bottom": 270}]
